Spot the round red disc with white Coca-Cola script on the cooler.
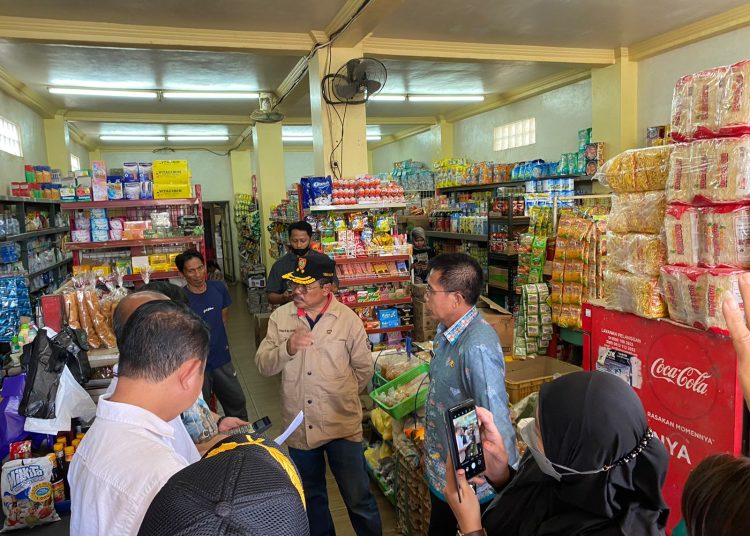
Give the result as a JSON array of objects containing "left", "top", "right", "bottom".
[{"left": 644, "top": 336, "right": 726, "bottom": 420}]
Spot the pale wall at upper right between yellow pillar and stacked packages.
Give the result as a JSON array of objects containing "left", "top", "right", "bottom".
[{"left": 638, "top": 28, "right": 750, "bottom": 143}]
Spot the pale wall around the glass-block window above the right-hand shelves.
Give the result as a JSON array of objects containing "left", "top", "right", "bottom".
[{"left": 453, "top": 80, "right": 591, "bottom": 162}]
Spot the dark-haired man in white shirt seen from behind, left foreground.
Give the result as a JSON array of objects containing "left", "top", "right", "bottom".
[{"left": 69, "top": 300, "right": 209, "bottom": 536}]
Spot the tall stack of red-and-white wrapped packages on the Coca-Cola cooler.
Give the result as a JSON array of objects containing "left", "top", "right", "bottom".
[{"left": 661, "top": 61, "right": 750, "bottom": 333}]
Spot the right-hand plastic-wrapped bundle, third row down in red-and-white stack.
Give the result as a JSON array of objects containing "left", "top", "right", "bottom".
[{"left": 698, "top": 205, "right": 750, "bottom": 268}]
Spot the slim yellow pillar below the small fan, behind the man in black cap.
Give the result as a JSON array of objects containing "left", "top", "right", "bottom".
[{"left": 254, "top": 123, "right": 286, "bottom": 272}]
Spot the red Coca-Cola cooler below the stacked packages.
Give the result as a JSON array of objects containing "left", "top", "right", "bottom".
[{"left": 583, "top": 305, "right": 743, "bottom": 531}]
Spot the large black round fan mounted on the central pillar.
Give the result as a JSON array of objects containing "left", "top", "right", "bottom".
[{"left": 321, "top": 58, "right": 388, "bottom": 104}]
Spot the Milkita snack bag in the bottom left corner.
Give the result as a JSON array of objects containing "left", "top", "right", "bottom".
[{"left": 0, "top": 457, "right": 60, "bottom": 532}]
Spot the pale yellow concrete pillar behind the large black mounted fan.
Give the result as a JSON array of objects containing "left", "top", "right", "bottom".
[{"left": 309, "top": 46, "right": 368, "bottom": 178}]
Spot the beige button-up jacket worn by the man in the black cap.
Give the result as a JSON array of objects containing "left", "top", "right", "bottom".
[{"left": 255, "top": 297, "right": 373, "bottom": 450}]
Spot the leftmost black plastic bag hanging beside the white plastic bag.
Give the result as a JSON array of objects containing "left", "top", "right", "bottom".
[{"left": 18, "top": 329, "right": 67, "bottom": 419}]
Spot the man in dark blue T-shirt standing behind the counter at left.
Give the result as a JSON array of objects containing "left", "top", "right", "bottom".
[{"left": 175, "top": 250, "right": 249, "bottom": 421}]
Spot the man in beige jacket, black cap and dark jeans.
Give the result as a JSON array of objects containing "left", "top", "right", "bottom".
[{"left": 255, "top": 256, "right": 382, "bottom": 536}]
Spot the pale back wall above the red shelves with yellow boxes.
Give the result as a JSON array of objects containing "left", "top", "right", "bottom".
[{"left": 102, "top": 147, "right": 234, "bottom": 201}]
